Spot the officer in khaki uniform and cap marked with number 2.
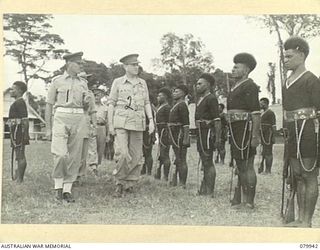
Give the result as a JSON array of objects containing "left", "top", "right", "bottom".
[{"left": 108, "top": 54, "right": 154, "bottom": 197}]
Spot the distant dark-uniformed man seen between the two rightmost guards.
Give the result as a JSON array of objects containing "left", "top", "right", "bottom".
[{"left": 258, "top": 98, "right": 276, "bottom": 174}]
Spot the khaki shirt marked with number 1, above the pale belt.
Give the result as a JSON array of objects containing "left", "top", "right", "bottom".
[{"left": 47, "top": 72, "right": 88, "bottom": 108}]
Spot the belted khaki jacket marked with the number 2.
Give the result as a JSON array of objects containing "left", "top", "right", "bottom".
[{"left": 108, "top": 76, "right": 150, "bottom": 131}]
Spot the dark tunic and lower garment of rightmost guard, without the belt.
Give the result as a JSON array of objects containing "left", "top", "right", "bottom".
[{"left": 283, "top": 71, "right": 320, "bottom": 158}]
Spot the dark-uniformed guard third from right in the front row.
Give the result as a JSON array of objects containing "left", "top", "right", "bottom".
[{"left": 195, "top": 73, "right": 221, "bottom": 197}]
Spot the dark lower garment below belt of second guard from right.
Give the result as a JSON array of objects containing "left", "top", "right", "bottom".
[{"left": 230, "top": 121, "right": 256, "bottom": 160}]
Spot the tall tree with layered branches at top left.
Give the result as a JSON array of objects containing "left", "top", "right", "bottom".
[{"left": 3, "top": 14, "right": 67, "bottom": 84}]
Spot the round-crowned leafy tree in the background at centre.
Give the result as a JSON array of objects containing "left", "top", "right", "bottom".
[{"left": 160, "top": 33, "right": 214, "bottom": 101}]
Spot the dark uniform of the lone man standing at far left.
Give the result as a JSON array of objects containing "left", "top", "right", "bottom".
[{"left": 9, "top": 97, "right": 29, "bottom": 146}]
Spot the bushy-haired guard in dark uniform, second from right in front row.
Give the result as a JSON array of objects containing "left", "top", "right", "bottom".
[{"left": 227, "top": 53, "right": 260, "bottom": 208}]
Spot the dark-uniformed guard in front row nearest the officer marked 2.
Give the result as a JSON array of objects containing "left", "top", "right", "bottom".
[{"left": 155, "top": 88, "right": 171, "bottom": 181}]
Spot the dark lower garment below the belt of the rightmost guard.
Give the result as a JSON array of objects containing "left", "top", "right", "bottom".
[{"left": 287, "top": 119, "right": 319, "bottom": 158}]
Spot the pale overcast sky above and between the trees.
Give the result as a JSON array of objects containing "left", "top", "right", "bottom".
[{"left": 5, "top": 15, "right": 320, "bottom": 97}]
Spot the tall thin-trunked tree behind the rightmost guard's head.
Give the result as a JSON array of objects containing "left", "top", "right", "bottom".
[{"left": 248, "top": 15, "right": 320, "bottom": 90}]
